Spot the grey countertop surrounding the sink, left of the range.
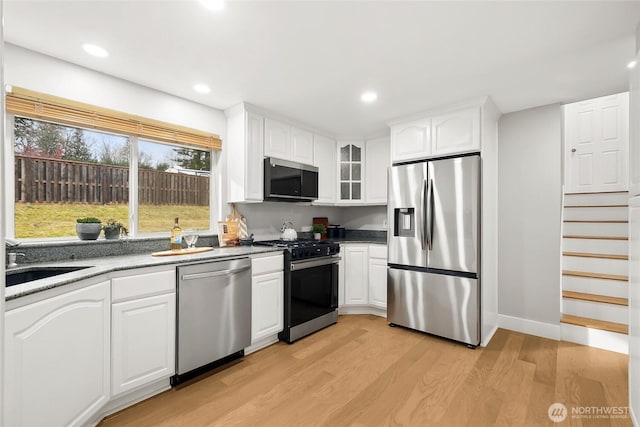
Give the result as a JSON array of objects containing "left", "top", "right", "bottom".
[{"left": 5, "top": 246, "right": 282, "bottom": 301}]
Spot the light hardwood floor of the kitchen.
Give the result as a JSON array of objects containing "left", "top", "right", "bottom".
[{"left": 100, "top": 315, "right": 631, "bottom": 427}]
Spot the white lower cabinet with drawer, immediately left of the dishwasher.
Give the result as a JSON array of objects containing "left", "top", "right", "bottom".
[{"left": 111, "top": 268, "right": 176, "bottom": 396}]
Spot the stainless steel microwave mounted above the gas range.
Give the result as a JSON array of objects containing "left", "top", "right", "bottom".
[{"left": 264, "top": 157, "right": 318, "bottom": 202}]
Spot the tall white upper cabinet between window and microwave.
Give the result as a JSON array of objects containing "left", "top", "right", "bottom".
[{"left": 223, "top": 104, "right": 264, "bottom": 203}]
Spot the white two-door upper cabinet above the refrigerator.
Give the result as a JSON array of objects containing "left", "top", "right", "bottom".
[{"left": 391, "top": 106, "right": 480, "bottom": 163}]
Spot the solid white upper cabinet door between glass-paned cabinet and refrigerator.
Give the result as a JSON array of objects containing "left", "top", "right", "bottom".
[{"left": 364, "top": 137, "right": 391, "bottom": 205}]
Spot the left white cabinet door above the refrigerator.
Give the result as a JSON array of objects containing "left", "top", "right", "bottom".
[{"left": 391, "top": 119, "right": 431, "bottom": 162}]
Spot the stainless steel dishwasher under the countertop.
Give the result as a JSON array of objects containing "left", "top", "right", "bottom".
[{"left": 171, "top": 258, "right": 251, "bottom": 385}]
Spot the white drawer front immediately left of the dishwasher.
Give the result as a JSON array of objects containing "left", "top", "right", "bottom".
[{"left": 111, "top": 270, "right": 176, "bottom": 302}]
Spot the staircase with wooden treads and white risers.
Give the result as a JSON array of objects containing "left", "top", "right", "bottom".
[{"left": 561, "top": 192, "right": 629, "bottom": 354}]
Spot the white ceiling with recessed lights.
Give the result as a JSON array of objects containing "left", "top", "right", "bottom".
[{"left": 4, "top": 0, "right": 640, "bottom": 137}]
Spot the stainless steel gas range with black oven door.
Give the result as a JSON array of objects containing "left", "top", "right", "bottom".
[{"left": 254, "top": 239, "right": 340, "bottom": 344}]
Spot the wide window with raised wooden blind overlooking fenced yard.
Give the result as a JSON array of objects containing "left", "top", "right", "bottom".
[{"left": 7, "top": 89, "right": 220, "bottom": 238}]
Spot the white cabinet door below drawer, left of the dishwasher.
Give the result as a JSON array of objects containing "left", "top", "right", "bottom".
[{"left": 111, "top": 293, "right": 176, "bottom": 396}]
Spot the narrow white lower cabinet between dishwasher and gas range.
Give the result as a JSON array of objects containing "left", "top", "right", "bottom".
[{"left": 251, "top": 254, "right": 284, "bottom": 350}]
